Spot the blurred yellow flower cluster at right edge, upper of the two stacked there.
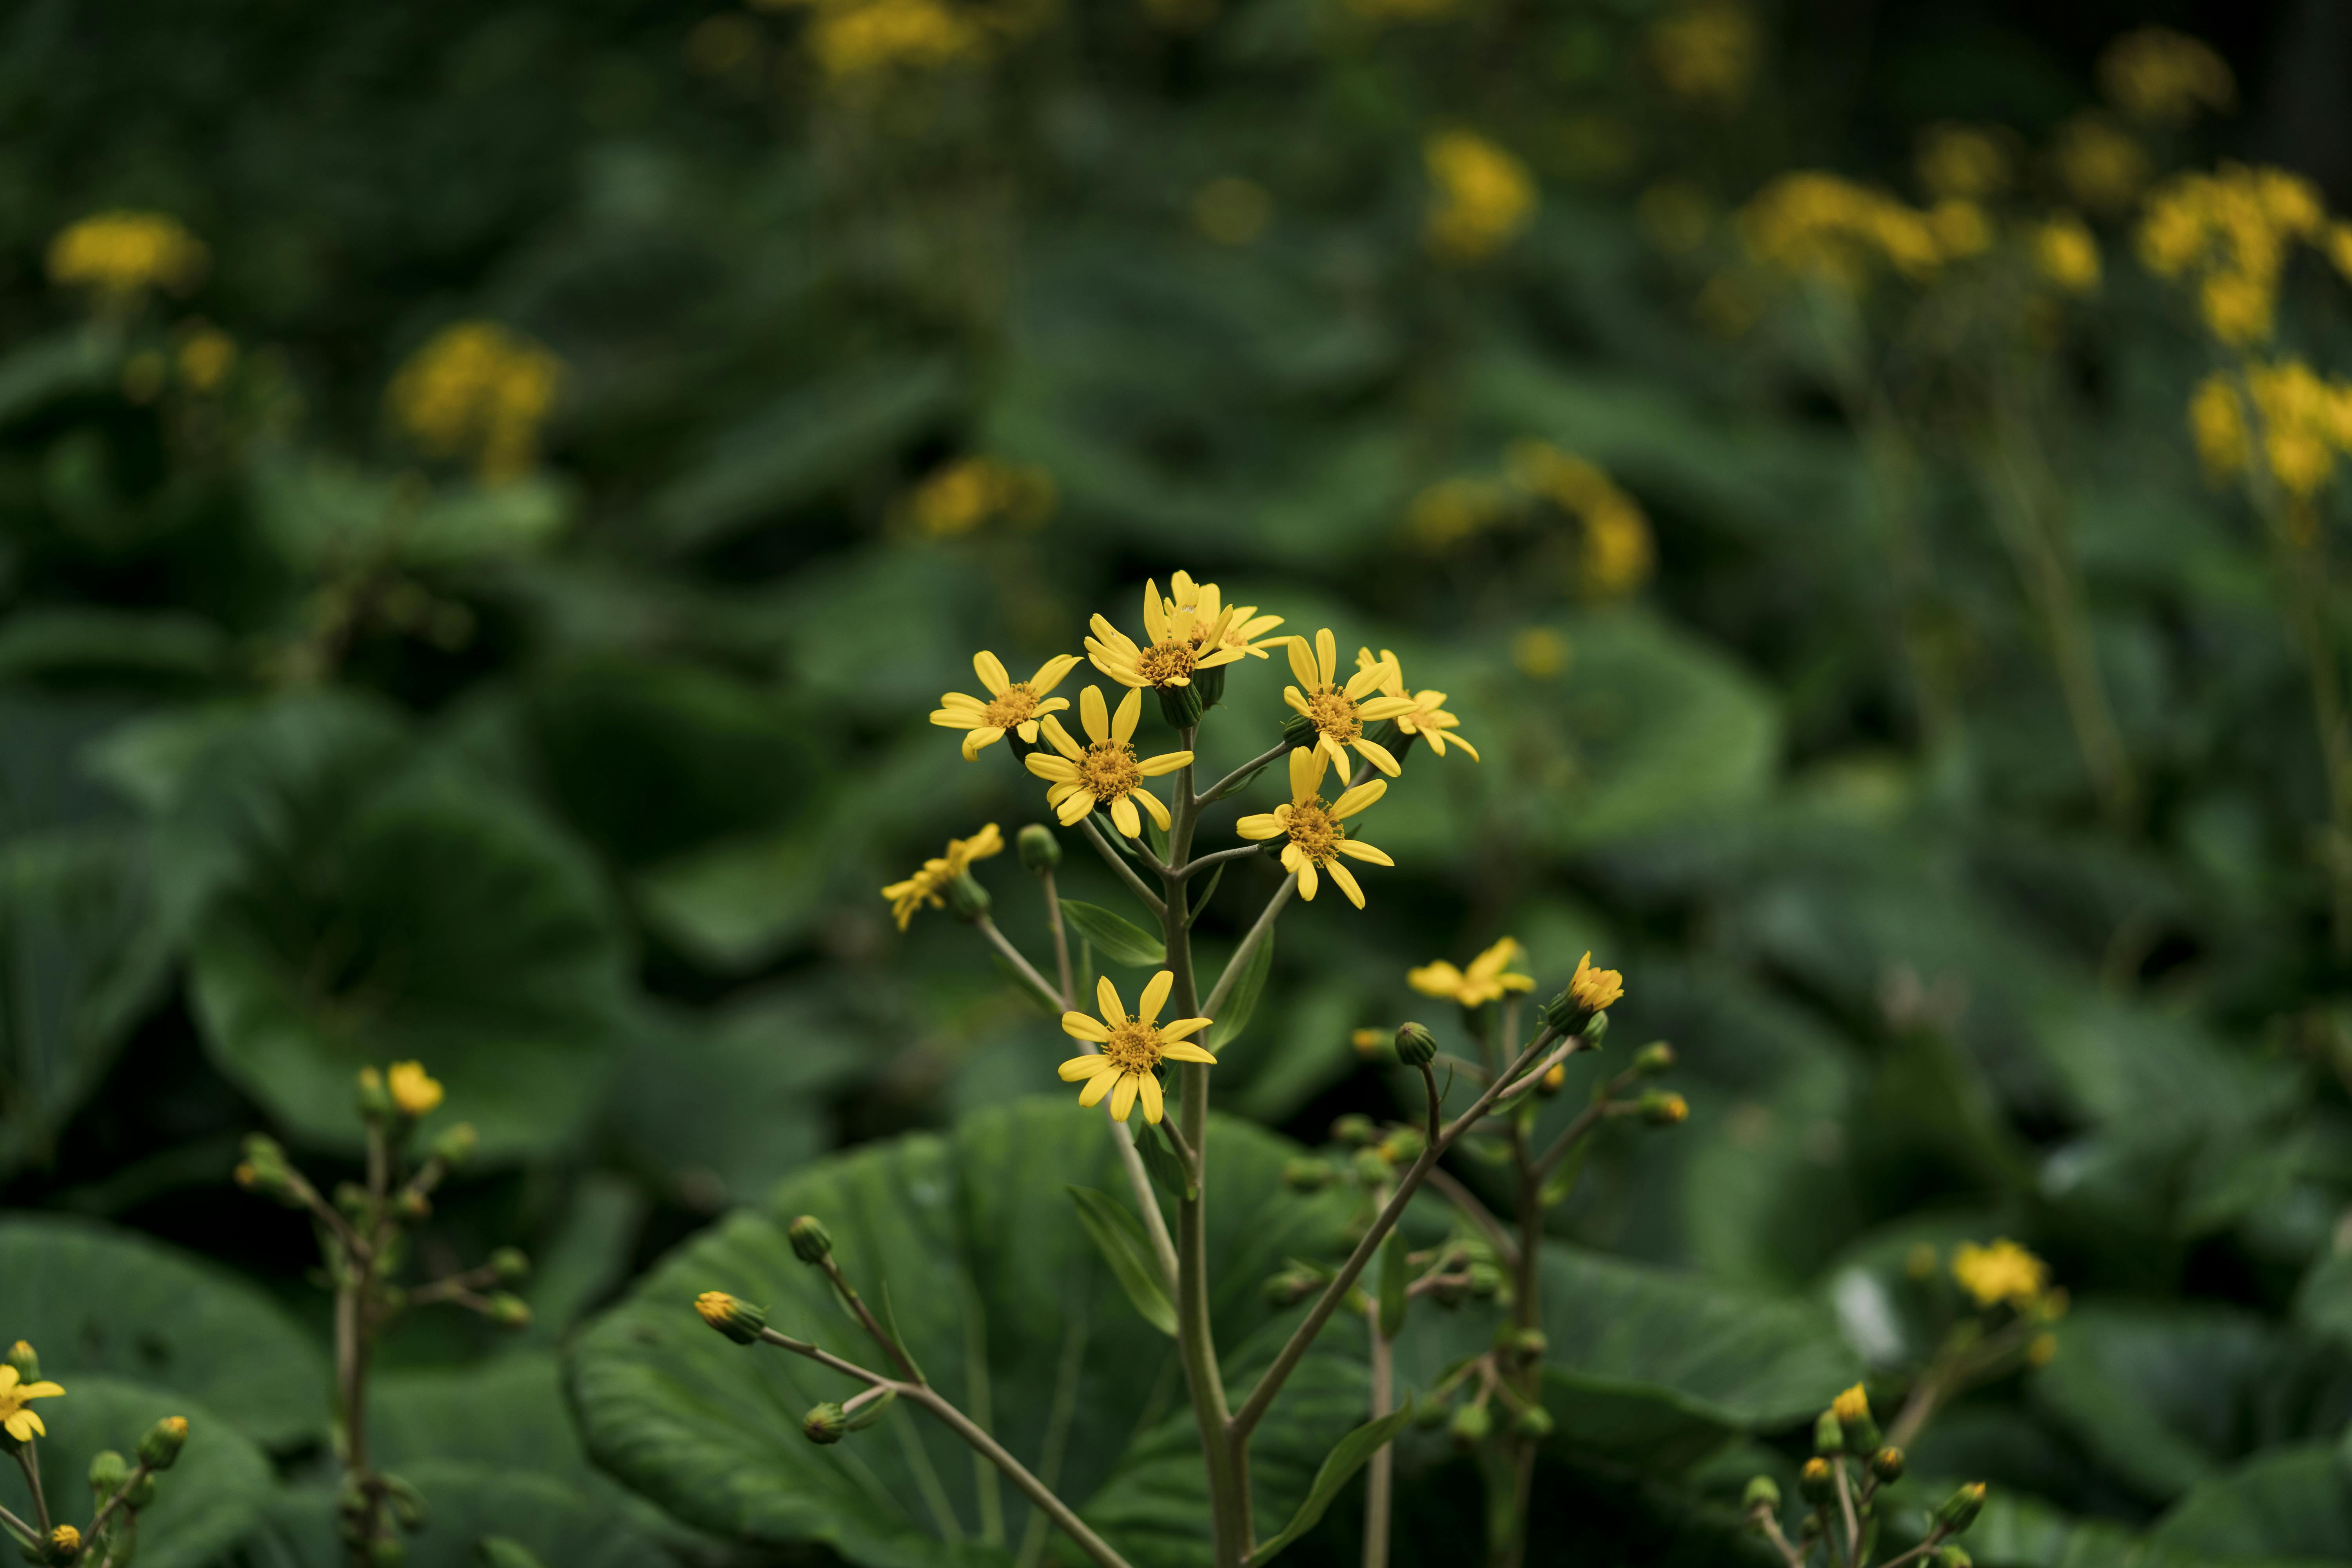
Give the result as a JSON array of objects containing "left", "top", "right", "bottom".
[{"left": 2138, "top": 162, "right": 2352, "bottom": 348}]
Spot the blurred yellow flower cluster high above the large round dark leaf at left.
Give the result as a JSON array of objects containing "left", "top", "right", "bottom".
[{"left": 386, "top": 322, "right": 562, "bottom": 479}]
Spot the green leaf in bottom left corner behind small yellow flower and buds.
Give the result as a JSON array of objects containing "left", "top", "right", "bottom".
[{"left": 24, "top": 1354, "right": 273, "bottom": 1568}]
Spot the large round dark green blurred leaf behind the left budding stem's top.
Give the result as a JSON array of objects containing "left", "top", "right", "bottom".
[{"left": 160, "top": 696, "right": 626, "bottom": 1154}]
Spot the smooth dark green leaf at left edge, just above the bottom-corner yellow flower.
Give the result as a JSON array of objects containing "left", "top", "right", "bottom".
[{"left": 0, "top": 1213, "right": 327, "bottom": 1448}]
